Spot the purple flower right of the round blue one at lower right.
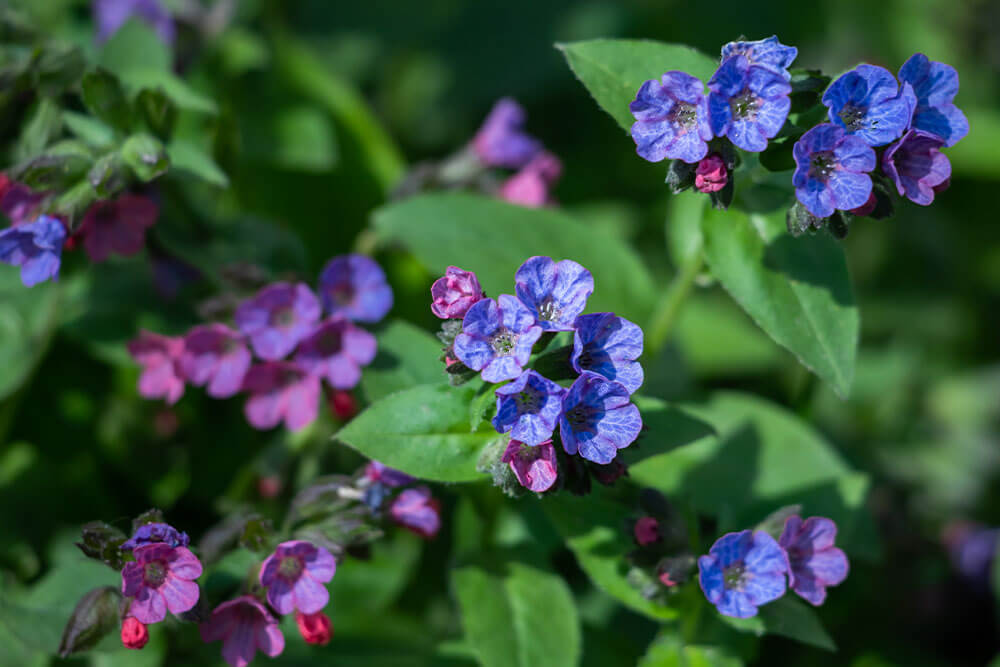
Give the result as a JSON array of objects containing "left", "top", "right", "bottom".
[{"left": 779, "top": 516, "right": 848, "bottom": 606}]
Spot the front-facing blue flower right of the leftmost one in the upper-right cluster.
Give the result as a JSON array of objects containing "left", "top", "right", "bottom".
[{"left": 708, "top": 55, "right": 792, "bottom": 153}]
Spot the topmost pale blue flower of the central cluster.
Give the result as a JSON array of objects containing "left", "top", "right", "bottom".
[{"left": 516, "top": 257, "right": 594, "bottom": 332}]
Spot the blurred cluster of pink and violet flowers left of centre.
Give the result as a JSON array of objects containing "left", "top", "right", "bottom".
[{"left": 129, "top": 255, "right": 393, "bottom": 430}]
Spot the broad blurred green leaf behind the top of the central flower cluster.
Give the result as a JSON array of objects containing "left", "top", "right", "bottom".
[{"left": 373, "top": 194, "right": 654, "bottom": 323}]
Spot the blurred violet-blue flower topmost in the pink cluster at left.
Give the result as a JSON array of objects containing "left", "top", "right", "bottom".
[{"left": 319, "top": 255, "right": 392, "bottom": 323}]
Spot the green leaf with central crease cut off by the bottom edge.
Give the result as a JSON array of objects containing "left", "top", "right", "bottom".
[{"left": 451, "top": 563, "right": 582, "bottom": 667}]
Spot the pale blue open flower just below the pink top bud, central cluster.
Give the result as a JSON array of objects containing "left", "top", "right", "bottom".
[{"left": 454, "top": 294, "right": 542, "bottom": 382}]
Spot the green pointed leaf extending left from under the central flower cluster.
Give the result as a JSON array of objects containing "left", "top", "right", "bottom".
[{"left": 336, "top": 385, "right": 501, "bottom": 482}]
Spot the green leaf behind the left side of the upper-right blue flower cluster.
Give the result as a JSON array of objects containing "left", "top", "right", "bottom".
[{"left": 556, "top": 39, "right": 719, "bottom": 132}]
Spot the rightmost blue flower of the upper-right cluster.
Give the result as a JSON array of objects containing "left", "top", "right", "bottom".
[{"left": 899, "top": 53, "right": 969, "bottom": 146}]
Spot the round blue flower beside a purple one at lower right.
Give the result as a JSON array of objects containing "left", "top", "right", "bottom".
[{"left": 698, "top": 530, "right": 788, "bottom": 618}]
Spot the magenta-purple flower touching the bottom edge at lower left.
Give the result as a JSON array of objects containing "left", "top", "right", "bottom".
[{"left": 198, "top": 595, "right": 285, "bottom": 667}]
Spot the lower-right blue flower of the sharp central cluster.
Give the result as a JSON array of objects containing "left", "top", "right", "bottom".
[{"left": 559, "top": 371, "right": 642, "bottom": 464}]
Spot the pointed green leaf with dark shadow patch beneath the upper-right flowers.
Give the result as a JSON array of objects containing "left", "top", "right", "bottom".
[{"left": 702, "top": 210, "right": 860, "bottom": 397}]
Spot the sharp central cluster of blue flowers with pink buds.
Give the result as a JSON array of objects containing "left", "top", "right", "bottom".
[{"left": 431, "top": 257, "right": 643, "bottom": 492}]
